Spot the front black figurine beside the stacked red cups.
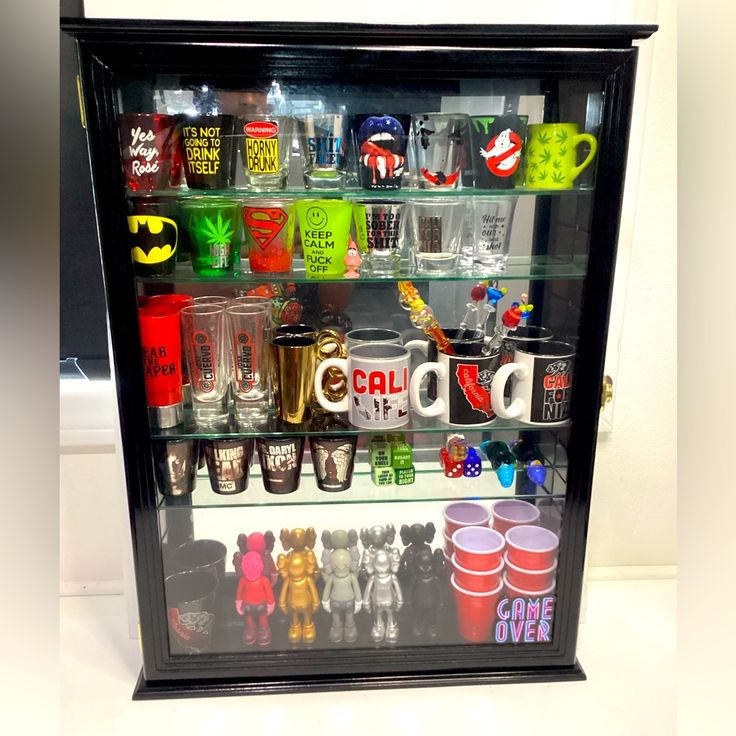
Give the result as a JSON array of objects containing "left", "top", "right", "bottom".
[{"left": 407, "top": 544, "right": 445, "bottom": 639}]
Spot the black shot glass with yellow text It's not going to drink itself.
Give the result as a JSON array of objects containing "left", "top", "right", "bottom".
[{"left": 178, "top": 115, "right": 235, "bottom": 189}]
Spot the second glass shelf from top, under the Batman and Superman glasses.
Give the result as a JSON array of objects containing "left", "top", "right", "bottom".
[{"left": 136, "top": 256, "right": 587, "bottom": 285}]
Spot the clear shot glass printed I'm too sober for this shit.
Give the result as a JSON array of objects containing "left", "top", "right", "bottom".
[{"left": 353, "top": 200, "right": 405, "bottom": 276}]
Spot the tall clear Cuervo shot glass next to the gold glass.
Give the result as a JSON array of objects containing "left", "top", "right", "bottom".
[{"left": 226, "top": 302, "right": 271, "bottom": 419}]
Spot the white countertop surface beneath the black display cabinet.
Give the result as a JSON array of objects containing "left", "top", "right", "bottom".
[{"left": 60, "top": 579, "right": 677, "bottom": 736}]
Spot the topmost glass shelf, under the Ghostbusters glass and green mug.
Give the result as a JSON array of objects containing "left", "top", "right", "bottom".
[{"left": 126, "top": 187, "right": 595, "bottom": 200}]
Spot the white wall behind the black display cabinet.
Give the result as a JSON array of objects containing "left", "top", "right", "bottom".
[{"left": 60, "top": 0, "right": 677, "bottom": 592}]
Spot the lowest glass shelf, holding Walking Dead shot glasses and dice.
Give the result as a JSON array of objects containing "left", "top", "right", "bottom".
[{"left": 159, "top": 459, "right": 565, "bottom": 510}]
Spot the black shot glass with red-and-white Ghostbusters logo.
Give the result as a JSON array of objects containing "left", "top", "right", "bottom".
[{"left": 470, "top": 115, "right": 529, "bottom": 189}]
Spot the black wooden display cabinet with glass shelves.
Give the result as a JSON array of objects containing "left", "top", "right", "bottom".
[{"left": 62, "top": 19, "right": 655, "bottom": 698}]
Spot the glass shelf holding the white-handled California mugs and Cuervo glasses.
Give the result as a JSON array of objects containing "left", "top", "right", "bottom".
[{"left": 151, "top": 411, "right": 570, "bottom": 439}]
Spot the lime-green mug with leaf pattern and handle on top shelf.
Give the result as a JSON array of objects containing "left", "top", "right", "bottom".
[{"left": 526, "top": 123, "right": 598, "bottom": 189}]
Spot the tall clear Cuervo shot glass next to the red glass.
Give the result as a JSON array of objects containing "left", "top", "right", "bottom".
[{"left": 181, "top": 304, "right": 229, "bottom": 425}]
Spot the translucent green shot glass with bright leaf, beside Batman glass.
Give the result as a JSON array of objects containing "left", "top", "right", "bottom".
[{"left": 179, "top": 197, "right": 240, "bottom": 277}]
